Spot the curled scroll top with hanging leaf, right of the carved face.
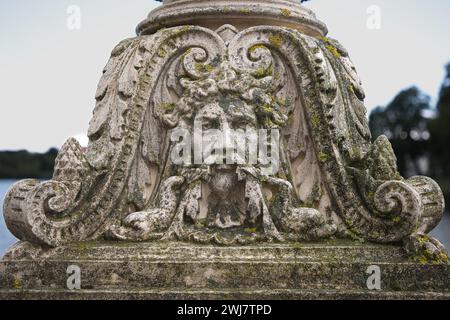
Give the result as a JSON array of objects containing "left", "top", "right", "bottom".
[{"left": 229, "top": 27, "right": 331, "bottom": 213}]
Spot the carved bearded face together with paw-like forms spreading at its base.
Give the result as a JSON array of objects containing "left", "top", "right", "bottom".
[{"left": 114, "top": 46, "right": 336, "bottom": 244}]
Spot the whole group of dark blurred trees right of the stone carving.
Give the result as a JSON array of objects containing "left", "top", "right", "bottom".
[{"left": 370, "top": 63, "right": 450, "bottom": 203}]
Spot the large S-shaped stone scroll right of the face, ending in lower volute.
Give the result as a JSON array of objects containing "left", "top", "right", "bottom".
[{"left": 229, "top": 27, "right": 443, "bottom": 242}]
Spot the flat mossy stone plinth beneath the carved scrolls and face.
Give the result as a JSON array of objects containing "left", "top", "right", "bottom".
[{"left": 0, "top": 242, "right": 450, "bottom": 299}]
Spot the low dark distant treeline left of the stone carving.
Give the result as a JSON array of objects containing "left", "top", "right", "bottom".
[{"left": 0, "top": 149, "right": 58, "bottom": 179}]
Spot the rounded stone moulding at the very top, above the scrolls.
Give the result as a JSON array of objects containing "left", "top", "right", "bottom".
[{"left": 137, "top": 0, "right": 328, "bottom": 36}]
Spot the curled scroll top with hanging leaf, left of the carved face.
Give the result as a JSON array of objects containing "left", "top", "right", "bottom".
[{"left": 126, "top": 27, "right": 224, "bottom": 212}]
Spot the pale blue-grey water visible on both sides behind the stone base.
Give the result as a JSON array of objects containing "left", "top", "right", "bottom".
[{"left": 0, "top": 180, "right": 450, "bottom": 257}]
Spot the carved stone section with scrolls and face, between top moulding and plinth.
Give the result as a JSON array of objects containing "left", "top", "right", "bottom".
[{"left": 4, "top": 21, "right": 447, "bottom": 261}]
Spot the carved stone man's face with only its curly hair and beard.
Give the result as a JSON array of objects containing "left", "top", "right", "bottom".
[{"left": 165, "top": 63, "right": 279, "bottom": 229}]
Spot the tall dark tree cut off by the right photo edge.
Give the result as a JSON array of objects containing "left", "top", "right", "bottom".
[{"left": 429, "top": 63, "right": 450, "bottom": 176}]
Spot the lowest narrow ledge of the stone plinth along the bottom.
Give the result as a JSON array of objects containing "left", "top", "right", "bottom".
[{"left": 0, "top": 289, "right": 450, "bottom": 300}]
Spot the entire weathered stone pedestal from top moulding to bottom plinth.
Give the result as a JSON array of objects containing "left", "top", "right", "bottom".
[{"left": 0, "top": 0, "right": 448, "bottom": 297}]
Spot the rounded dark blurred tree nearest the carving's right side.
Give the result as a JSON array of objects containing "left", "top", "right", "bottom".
[{"left": 369, "top": 87, "right": 431, "bottom": 176}]
